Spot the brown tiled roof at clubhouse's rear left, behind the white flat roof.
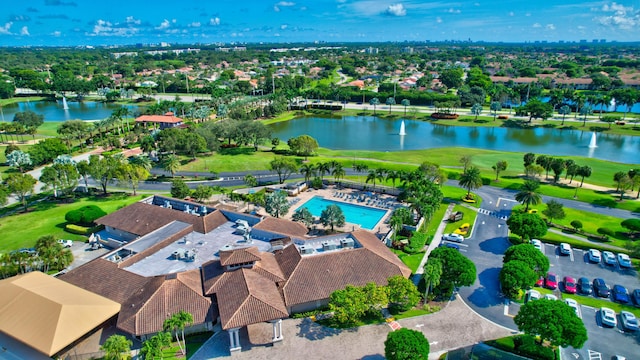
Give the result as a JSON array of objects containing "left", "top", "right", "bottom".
[{"left": 96, "top": 202, "right": 228, "bottom": 236}]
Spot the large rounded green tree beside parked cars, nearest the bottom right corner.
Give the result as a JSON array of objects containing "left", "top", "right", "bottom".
[{"left": 513, "top": 299, "right": 587, "bottom": 349}]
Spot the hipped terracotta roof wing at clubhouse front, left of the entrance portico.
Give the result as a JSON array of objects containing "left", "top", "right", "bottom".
[{"left": 117, "top": 270, "right": 212, "bottom": 336}]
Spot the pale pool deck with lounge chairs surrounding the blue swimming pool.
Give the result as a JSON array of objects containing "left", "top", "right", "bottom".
[{"left": 283, "top": 185, "right": 401, "bottom": 234}]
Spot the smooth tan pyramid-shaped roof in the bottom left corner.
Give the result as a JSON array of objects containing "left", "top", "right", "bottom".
[{"left": 0, "top": 271, "right": 120, "bottom": 358}]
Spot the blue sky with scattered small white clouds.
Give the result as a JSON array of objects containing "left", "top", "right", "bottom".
[{"left": 0, "top": 0, "right": 640, "bottom": 46}]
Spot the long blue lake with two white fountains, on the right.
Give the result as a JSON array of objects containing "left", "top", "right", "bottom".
[{"left": 269, "top": 116, "right": 640, "bottom": 164}]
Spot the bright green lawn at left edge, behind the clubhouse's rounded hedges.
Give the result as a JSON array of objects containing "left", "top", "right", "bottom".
[{"left": 0, "top": 194, "right": 148, "bottom": 251}]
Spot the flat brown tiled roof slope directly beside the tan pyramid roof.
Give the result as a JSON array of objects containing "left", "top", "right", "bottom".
[{"left": 59, "top": 258, "right": 149, "bottom": 304}]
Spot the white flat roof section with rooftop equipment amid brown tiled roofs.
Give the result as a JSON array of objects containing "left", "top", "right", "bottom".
[{"left": 124, "top": 221, "right": 271, "bottom": 276}]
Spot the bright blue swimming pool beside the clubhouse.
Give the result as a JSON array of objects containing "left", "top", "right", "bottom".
[{"left": 300, "top": 196, "right": 387, "bottom": 230}]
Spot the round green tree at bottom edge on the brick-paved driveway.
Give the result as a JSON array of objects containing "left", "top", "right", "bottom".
[{"left": 384, "top": 328, "right": 429, "bottom": 360}]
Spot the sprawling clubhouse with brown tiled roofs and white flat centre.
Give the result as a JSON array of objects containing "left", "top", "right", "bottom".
[{"left": 60, "top": 196, "right": 411, "bottom": 351}]
